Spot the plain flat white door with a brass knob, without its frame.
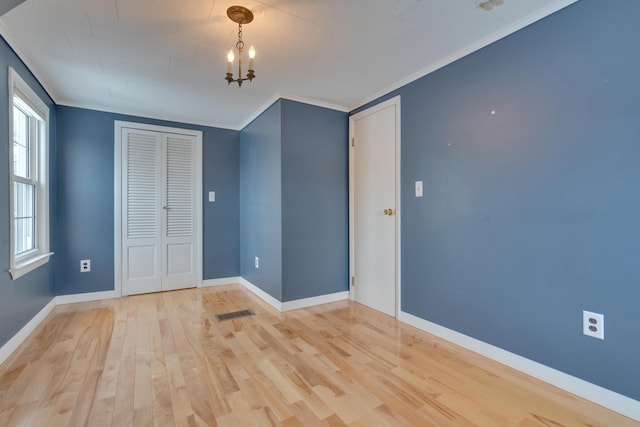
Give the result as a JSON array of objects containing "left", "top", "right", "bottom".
[{"left": 350, "top": 98, "right": 400, "bottom": 317}]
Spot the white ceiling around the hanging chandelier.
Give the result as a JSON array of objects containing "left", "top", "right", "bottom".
[{"left": 0, "top": 0, "right": 576, "bottom": 129}]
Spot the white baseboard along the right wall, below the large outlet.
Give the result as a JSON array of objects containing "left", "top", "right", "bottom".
[{"left": 398, "top": 311, "right": 640, "bottom": 421}]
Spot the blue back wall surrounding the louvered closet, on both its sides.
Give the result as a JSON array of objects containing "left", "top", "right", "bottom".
[{"left": 56, "top": 106, "right": 239, "bottom": 295}]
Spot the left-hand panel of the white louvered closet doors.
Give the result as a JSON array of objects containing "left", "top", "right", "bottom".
[{"left": 122, "top": 128, "right": 162, "bottom": 295}]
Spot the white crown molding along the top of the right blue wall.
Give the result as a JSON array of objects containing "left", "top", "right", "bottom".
[{"left": 349, "top": 0, "right": 578, "bottom": 111}]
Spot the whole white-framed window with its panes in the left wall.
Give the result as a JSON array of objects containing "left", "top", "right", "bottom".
[{"left": 9, "top": 68, "right": 52, "bottom": 279}]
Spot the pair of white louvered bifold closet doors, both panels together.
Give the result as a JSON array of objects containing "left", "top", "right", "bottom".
[{"left": 120, "top": 127, "right": 200, "bottom": 295}]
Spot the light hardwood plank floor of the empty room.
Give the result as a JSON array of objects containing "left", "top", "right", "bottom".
[{"left": 0, "top": 285, "right": 640, "bottom": 427}]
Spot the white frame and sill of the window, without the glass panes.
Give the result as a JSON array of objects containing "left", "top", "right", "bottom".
[{"left": 8, "top": 67, "right": 53, "bottom": 280}]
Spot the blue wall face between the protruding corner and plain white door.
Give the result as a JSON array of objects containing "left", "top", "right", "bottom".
[{"left": 282, "top": 100, "right": 349, "bottom": 301}]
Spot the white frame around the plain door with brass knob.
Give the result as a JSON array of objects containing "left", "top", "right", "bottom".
[{"left": 347, "top": 95, "right": 402, "bottom": 319}]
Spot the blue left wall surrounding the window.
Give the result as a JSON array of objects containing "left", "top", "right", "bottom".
[{"left": 0, "top": 39, "right": 57, "bottom": 346}]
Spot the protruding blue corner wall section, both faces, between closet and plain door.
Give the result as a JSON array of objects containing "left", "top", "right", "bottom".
[{"left": 240, "top": 100, "right": 349, "bottom": 302}]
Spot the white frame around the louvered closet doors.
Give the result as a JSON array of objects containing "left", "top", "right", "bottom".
[{"left": 113, "top": 120, "right": 203, "bottom": 297}]
